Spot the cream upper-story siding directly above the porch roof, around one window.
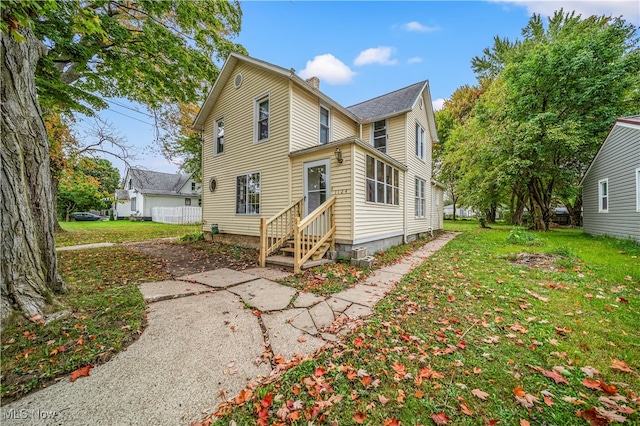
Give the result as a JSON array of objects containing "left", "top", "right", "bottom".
[{"left": 291, "top": 85, "right": 358, "bottom": 152}]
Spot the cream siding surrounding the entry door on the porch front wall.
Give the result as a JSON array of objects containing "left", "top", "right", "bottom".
[{"left": 291, "top": 147, "right": 353, "bottom": 241}]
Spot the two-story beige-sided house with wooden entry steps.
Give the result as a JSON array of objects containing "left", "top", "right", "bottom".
[{"left": 193, "top": 53, "right": 443, "bottom": 270}]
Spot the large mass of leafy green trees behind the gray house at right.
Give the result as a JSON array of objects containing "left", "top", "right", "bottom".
[{"left": 442, "top": 11, "right": 640, "bottom": 229}]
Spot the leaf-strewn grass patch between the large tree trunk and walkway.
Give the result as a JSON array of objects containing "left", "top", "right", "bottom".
[{"left": 0, "top": 246, "right": 168, "bottom": 403}]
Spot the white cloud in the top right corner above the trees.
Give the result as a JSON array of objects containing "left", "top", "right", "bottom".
[{"left": 492, "top": 0, "right": 640, "bottom": 25}]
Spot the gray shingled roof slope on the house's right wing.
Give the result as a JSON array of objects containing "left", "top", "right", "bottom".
[{"left": 347, "top": 80, "right": 427, "bottom": 121}]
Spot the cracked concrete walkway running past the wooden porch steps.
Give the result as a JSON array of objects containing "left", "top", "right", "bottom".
[{"left": 0, "top": 233, "right": 457, "bottom": 425}]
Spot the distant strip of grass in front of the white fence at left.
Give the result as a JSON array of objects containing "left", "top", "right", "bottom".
[{"left": 56, "top": 220, "right": 201, "bottom": 247}]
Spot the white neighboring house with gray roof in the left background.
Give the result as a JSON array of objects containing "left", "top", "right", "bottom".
[{"left": 114, "top": 167, "right": 202, "bottom": 220}]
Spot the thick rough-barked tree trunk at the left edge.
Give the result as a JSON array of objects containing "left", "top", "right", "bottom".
[{"left": 0, "top": 28, "right": 66, "bottom": 323}]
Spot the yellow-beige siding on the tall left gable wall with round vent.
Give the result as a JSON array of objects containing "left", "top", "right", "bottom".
[{"left": 202, "top": 62, "right": 291, "bottom": 236}]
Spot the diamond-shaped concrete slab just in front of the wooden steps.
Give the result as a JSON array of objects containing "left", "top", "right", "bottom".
[{"left": 228, "top": 278, "right": 296, "bottom": 312}]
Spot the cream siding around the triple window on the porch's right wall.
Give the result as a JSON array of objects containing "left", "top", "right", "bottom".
[{"left": 351, "top": 149, "right": 404, "bottom": 243}]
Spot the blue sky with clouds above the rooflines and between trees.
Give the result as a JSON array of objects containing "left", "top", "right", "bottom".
[{"left": 82, "top": 0, "right": 640, "bottom": 174}]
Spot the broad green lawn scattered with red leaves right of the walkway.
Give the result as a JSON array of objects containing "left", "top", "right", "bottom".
[{"left": 211, "top": 222, "right": 640, "bottom": 425}]
